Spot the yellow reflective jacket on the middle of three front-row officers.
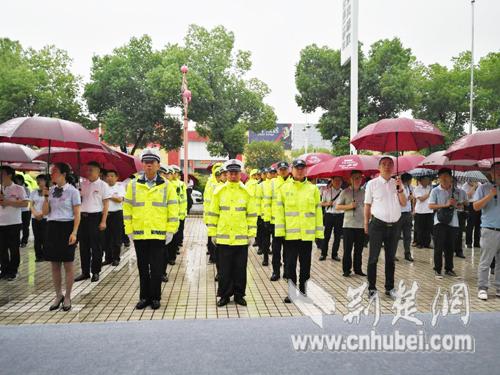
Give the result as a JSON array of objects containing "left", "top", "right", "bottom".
[{"left": 207, "top": 181, "right": 257, "bottom": 246}]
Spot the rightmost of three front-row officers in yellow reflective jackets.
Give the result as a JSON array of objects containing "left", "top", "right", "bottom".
[{"left": 274, "top": 159, "right": 323, "bottom": 303}]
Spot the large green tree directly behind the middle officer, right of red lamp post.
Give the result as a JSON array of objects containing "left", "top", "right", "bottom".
[{"left": 151, "top": 25, "right": 276, "bottom": 158}]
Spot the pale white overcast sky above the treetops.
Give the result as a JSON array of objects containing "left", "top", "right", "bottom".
[{"left": 0, "top": 0, "right": 500, "bottom": 122}]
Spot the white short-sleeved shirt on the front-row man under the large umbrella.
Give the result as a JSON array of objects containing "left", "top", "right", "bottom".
[{"left": 365, "top": 176, "right": 401, "bottom": 223}]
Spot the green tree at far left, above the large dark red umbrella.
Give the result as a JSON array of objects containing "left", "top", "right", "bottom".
[{"left": 0, "top": 38, "right": 85, "bottom": 126}]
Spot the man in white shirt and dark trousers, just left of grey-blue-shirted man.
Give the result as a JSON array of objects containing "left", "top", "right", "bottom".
[{"left": 413, "top": 176, "right": 434, "bottom": 249}]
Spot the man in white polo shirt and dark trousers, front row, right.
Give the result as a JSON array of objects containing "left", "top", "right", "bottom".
[{"left": 364, "top": 157, "right": 407, "bottom": 300}]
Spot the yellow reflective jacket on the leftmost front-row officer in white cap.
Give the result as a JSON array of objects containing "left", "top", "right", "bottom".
[{"left": 123, "top": 175, "right": 179, "bottom": 240}]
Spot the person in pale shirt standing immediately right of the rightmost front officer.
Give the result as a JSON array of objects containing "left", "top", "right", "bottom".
[{"left": 319, "top": 176, "right": 344, "bottom": 262}]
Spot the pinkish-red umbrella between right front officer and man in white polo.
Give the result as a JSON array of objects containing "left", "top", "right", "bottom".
[{"left": 307, "top": 155, "right": 378, "bottom": 180}]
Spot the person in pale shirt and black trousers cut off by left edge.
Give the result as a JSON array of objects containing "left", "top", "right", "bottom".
[{"left": 0, "top": 166, "right": 29, "bottom": 281}]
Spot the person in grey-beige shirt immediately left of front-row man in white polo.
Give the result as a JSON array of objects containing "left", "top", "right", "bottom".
[{"left": 335, "top": 170, "right": 366, "bottom": 277}]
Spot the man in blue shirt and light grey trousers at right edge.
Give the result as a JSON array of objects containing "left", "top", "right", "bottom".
[{"left": 473, "top": 163, "right": 500, "bottom": 300}]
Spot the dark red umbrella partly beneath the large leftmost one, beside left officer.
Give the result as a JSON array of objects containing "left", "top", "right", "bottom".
[{"left": 35, "top": 146, "right": 142, "bottom": 181}]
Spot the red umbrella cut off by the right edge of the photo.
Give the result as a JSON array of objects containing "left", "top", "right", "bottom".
[{"left": 444, "top": 129, "right": 500, "bottom": 160}]
